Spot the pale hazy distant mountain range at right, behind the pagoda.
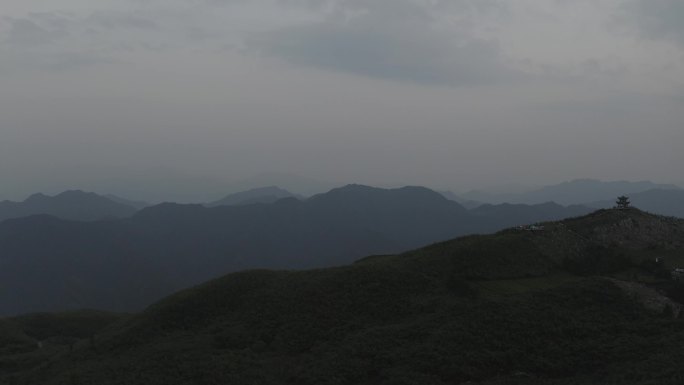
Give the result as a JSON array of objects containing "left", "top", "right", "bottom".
[{"left": 456, "top": 179, "right": 680, "bottom": 205}]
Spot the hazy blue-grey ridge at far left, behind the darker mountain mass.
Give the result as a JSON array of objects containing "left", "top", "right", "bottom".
[{"left": 0, "top": 191, "right": 137, "bottom": 222}]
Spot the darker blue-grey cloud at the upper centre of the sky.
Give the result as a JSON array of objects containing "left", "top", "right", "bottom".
[{"left": 247, "top": 0, "right": 519, "bottom": 86}]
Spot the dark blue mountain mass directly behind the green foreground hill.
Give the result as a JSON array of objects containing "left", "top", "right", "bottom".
[{"left": 0, "top": 185, "right": 592, "bottom": 314}]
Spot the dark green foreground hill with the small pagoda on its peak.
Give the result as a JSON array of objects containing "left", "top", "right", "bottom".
[{"left": 6, "top": 210, "right": 684, "bottom": 385}]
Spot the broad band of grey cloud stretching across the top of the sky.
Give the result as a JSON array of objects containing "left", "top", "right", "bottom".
[{"left": 0, "top": 0, "right": 684, "bottom": 80}]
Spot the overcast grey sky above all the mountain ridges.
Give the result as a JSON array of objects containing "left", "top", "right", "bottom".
[{"left": 0, "top": 0, "right": 684, "bottom": 201}]
